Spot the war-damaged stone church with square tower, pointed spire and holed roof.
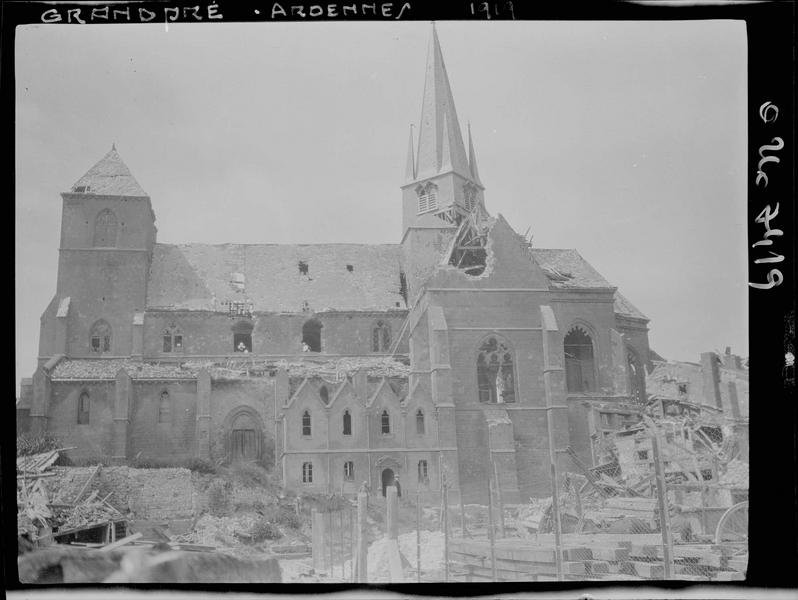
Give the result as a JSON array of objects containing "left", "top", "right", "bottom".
[{"left": 18, "top": 28, "right": 650, "bottom": 501}]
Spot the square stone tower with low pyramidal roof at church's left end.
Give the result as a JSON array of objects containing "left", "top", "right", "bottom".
[{"left": 39, "top": 147, "right": 157, "bottom": 359}]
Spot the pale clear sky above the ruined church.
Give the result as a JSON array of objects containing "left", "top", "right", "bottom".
[{"left": 15, "top": 21, "right": 748, "bottom": 390}]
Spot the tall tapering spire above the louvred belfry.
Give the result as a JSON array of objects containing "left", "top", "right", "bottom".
[{"left": 416, "top": 23, "right": 470, "bottom": 178}]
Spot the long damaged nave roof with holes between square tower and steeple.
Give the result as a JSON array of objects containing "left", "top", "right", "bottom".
[{"left": 147, "top": 244, "right": 407, "bottom": 312}]
